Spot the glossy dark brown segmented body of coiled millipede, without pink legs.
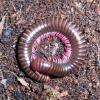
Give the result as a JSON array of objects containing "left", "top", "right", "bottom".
[{"left": 18, "top": 16, "right": 86, "bottom": 81}]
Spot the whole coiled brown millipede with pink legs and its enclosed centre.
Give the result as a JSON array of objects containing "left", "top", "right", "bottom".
[{"left": 18, "top": 16, "right": 86, "bottom": 82}]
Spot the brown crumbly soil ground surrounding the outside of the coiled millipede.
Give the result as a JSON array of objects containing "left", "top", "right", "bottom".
[{"left": 0, "top": 0, "right": 100, "bottom": 100}]
